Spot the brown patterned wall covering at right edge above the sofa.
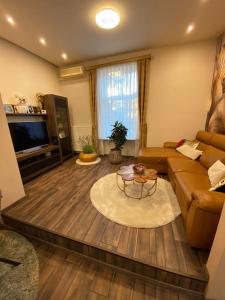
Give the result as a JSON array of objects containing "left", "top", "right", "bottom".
[{"left": 206, "top": 34, "right": 225, "bottom": 133}]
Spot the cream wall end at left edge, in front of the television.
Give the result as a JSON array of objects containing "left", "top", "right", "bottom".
[{"left": 0, "top": 96, "right": 25, "bottom": 209}]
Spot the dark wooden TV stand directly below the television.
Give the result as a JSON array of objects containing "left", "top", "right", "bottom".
[{"left": 16, "top": 145, "right": 62, "bottom": 182}]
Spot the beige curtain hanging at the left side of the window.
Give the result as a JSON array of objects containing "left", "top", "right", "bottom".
[{"left": 89, "top": 69, "right": 98, "bottom": 152}]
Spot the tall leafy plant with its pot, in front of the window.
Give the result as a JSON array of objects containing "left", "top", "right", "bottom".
[{"left": 108, "top": 121, "right": 128, "bottom": 164}]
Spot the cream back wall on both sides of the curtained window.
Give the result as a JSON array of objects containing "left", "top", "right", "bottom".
[{"left": 60, "top": 40, "right": 216, "bottom": 146}]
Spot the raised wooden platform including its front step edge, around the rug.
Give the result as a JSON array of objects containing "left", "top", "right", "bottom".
[{"left": 2, "top": 158, "right": 208, "bottom": 294}]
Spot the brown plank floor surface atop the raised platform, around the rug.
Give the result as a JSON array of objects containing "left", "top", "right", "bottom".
[{"left": 4, "top": 157, "right": 208, "bottom": 276}]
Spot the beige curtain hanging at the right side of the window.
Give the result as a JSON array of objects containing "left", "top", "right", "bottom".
[{"left": 138, "top": 58, "right": 150, "bottom": 148}]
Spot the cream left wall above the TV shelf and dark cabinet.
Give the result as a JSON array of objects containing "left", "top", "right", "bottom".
[{"left": 0, "top": 39, "right": 59, "bottom": 105}]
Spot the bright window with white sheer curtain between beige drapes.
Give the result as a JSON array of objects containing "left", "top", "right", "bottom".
[{"left": 97, "top": 62, "right": 139, "bottom": 140}]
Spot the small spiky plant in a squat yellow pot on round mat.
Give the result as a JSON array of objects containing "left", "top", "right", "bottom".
[{"left": 78, "top": 135, "right": 98, "bottom": 162}]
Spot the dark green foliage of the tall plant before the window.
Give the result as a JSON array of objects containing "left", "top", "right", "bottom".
[{"left": 108, "top": 121, "right": 128, "bottom": 150}]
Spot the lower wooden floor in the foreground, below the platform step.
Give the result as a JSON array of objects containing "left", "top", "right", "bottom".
[{"left": 32, "top": 240, "right": 201, "bottom": 300}]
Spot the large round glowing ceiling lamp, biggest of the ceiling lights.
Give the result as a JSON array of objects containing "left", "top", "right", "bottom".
[{"left": 95, "top": 8, "right": 120, "bottom": 29}]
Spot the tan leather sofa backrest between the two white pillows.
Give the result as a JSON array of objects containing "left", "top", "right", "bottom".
[{"left": 196, "top": 131, "right": 225, "bottom": 169}]
